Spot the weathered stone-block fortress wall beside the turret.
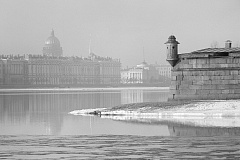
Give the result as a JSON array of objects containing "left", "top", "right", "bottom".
[{"left": 169, "top": 53, "right": 240, "bottom": 100}]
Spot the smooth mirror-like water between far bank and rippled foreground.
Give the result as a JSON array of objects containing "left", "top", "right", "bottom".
[{"left": 3, "top": 89, "right": 240, "bottom": 136}]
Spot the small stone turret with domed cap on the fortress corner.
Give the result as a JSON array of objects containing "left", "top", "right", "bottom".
[{"left": 165, "top": 35, "right": 179, "bottom": 67}]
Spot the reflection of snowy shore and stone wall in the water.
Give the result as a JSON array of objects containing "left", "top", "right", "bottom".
[{"left": 102, "top": 116, "right": 240, "bottom": 137}]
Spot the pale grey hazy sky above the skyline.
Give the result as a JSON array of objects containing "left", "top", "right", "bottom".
[{"left": 0, "top": 0, "right": 240, "bottom": 67}]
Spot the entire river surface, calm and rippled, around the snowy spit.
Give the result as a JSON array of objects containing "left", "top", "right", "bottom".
[{"left": 0, "top": 88, "right": 240, "bottom": 159}]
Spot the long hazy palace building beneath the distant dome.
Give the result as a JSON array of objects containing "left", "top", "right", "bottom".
[{"left": 0, "top": 54, "right": 121, "bottom": 87}]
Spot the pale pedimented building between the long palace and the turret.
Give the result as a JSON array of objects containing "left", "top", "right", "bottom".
[{"left": 121, "top": 61, "right": 158, "bottom": 84}]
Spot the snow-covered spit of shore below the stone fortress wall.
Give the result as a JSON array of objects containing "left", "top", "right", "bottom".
[{"left": 70, "top": 100, "right": 240, "bottom": 127}]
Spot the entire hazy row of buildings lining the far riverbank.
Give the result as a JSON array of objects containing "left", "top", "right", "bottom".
[{"left": 0, "top": 53, "right": 171, "bottom": 87}]
